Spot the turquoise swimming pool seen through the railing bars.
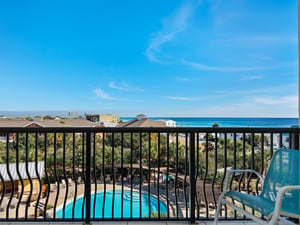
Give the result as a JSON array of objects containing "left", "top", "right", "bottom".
[{"left": 56, "top": 190, "right": 167, "bottom": 219}]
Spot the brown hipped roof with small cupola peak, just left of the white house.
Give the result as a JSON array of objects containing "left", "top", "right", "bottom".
[{"left": 119, "top": 114, "right": 167, "bottom": 127}]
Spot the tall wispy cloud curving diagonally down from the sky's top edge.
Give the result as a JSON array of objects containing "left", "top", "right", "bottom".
[{"left": 146, "top": 2, "right": 198, "bottom": 63}]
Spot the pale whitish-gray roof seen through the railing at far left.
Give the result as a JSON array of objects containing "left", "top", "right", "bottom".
[{"left": 0, "top": 161, "right": 45, "bottom": 181}]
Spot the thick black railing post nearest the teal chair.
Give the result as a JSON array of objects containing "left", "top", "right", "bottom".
[{"left": 189, "top": 132, "right": 196, "bottom": 224}]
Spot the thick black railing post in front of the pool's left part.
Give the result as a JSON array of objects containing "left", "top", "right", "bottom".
[{"left": 84, "top": 132, "right": 92, "bottom": 225}]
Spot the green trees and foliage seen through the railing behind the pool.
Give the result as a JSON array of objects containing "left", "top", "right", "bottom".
[{"left": 0, "top": 130, "right": 271, "bottom": 185}]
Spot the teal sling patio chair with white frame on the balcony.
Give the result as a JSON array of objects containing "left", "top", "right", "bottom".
[{"left": 214, "top": 149, "right": 300, "bottom": 225}]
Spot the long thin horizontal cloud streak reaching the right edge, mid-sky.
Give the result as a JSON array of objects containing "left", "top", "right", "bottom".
[{"left": 182, "top": 60, "right": 297, "bottom": 72}]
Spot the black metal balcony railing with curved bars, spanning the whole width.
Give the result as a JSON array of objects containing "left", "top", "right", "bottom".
[{"left": 0, "top": 127, "right": 299, "bottom": 223}]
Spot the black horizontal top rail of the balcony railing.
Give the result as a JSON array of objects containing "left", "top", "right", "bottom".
[{"left": 0, "top": 127, "right": 300, "bottom": 133}]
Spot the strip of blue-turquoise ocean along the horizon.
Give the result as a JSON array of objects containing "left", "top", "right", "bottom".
[{"left": 120, "top": 117, "right": 299, "bottom": 127}]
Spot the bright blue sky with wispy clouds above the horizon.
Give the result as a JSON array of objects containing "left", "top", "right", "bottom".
[{"left": 0, "top": 0, "right": 298, "bottom": 117}]
